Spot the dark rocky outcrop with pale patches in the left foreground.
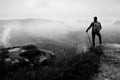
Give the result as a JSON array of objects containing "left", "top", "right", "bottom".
[{"left": 0, "top": 45, "right": 55, "bottom": 66}]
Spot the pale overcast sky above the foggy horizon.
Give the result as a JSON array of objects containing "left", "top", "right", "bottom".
[{"left": 0, "top": 0, "right": 120, "bottom": 20}]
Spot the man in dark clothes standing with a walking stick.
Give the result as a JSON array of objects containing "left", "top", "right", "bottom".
[{"left": 86, "top": 17, "right": 102, "bottom": 47}]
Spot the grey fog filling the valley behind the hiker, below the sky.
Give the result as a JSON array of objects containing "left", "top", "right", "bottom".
[{"left": 0, "top": 18, "right": 120, "bottom": 49}]
